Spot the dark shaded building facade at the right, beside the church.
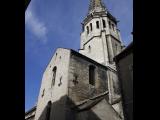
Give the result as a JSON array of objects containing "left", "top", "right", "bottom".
[{"left": 114, "top": 42, "right": 133, "bottom": 120}]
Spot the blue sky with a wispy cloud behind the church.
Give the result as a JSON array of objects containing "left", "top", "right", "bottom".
[{"left": 25, "top": 0, "right": 133, "bottom": 111}]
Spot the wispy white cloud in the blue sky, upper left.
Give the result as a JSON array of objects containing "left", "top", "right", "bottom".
[{"left": 25, "top": 9, "right": 47, "bottom": 43}]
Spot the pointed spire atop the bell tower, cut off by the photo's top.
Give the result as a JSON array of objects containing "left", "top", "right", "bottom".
[{"left": 88, "top": 0, "right": 106, "bottom": 14}]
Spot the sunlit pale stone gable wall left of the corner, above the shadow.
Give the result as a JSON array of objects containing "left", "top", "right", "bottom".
[{"left": 35, "top": 48, "right": 70, "bottom": 120}]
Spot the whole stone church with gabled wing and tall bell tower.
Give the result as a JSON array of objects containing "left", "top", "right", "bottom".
[{"left": 25, "top": 0, "right": 125, "bottom": 120}]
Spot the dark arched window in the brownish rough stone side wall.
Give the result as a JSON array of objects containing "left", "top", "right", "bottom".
[{"left": 89, "top": 65, "right": 95, "bottom": 86}]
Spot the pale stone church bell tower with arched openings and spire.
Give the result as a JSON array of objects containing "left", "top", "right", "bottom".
[{"left": 79, "top": 0, "right": 123, "bottom": 66}]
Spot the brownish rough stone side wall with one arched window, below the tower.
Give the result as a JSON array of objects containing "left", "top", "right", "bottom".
[{"left": 69, "top": 54, "right": 108, "bottom": 102}]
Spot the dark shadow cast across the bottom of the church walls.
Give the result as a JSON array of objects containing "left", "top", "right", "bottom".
[{"left": 38, "top": 96, "right": 101, "bottom": 120}]
